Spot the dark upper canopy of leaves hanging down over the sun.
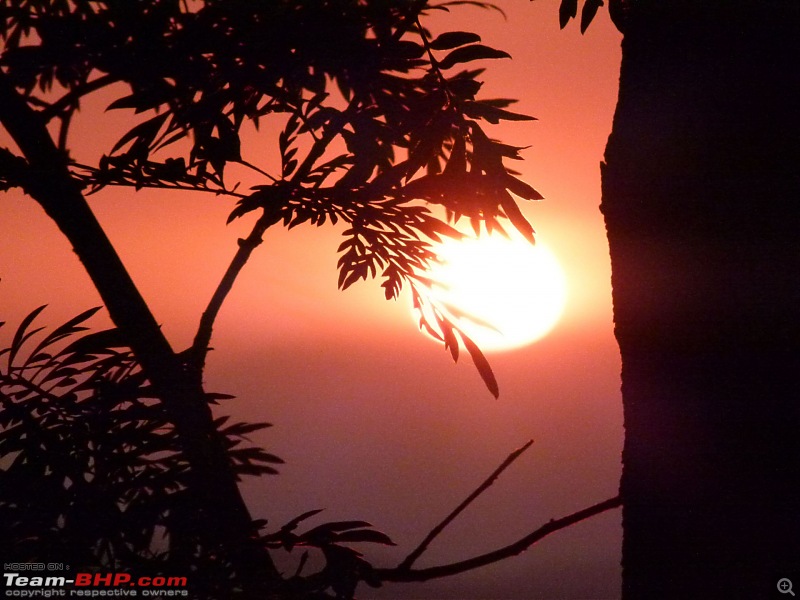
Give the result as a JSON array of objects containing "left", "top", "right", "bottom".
[{"left": 0, "top": 0, "right": 541, "bottom": 394}]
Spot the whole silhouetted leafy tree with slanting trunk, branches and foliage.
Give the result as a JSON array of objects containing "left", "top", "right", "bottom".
[{"left": 0, "top": 0, "right": 618, "bottom": 598}]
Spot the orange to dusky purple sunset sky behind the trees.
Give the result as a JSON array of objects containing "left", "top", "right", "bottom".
[{"left": 0, "top": 0, "right": 623, "bottom": 600}]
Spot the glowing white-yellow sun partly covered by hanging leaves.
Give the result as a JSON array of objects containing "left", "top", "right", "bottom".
[{"left": 416, "top": 234, "right": 567, "bottom": 351}]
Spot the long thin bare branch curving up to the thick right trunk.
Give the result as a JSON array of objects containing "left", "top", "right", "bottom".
[{"left": 370, "top": 496, "right": 622, "bottom": 582}]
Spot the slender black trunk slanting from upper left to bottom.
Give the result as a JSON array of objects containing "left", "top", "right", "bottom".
[{"left": 0, "top": 72, "right": 279, "bottom": 599}]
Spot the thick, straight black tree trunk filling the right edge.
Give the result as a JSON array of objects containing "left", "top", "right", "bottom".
[{"left": 602, "top": 0, "right": 800, "bottom": 600}]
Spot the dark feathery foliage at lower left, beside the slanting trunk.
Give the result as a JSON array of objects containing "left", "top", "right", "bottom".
[{"left": 0, "top": 306, "right": 282, "bottom": 579}]
